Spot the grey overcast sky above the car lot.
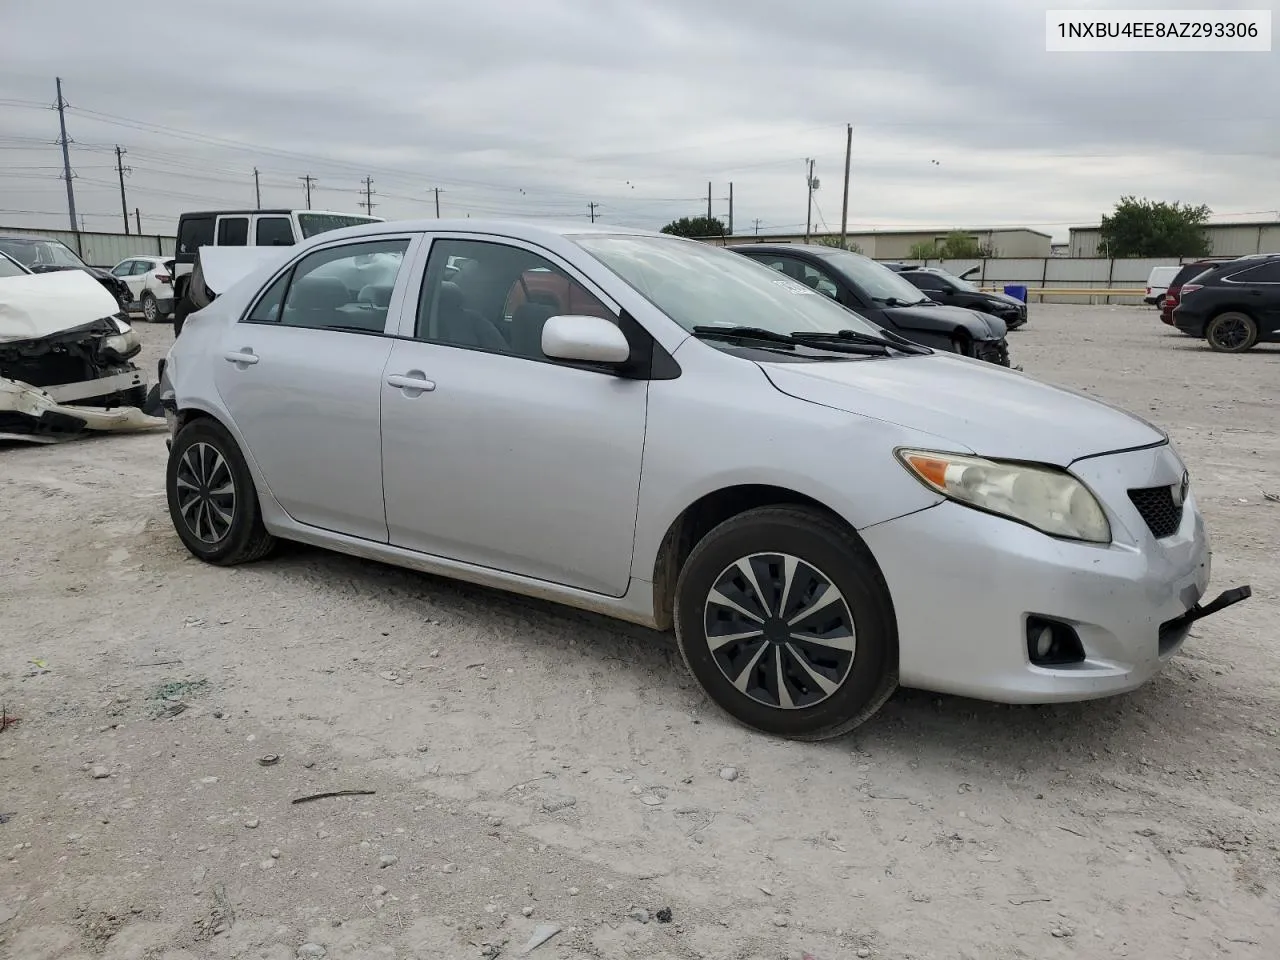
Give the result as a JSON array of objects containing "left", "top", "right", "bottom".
[{"left": 0, "top": 0, "right": 1280, "bottom": 238}]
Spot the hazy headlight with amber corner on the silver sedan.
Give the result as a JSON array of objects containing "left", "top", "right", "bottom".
[{"left": 897, "top": 451, "right": 1111, "bottom": 543}]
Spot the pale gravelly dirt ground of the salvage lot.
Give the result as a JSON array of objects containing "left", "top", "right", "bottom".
[{"left": 0, "top": 306, "right": 1280, "bottom": 960}]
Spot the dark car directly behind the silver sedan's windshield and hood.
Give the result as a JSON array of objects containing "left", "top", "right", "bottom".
[{"left": 730, "top": 243, "right": 1009, "bottom": 366}]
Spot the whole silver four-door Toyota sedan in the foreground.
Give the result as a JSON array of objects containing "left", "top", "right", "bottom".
[{"left": 161, "top": 220, "right": 1248, "bottom": 739}]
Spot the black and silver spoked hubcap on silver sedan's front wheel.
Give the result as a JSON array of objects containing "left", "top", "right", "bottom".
[{"left": 703, "top": 553, "right": 856, "bottom": 710}]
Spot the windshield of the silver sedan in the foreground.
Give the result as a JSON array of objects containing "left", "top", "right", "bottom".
[{"left": 573, "top": 234, "right": 882, "bottom": 337}]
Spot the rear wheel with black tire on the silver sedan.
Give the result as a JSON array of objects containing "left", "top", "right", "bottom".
[{"left": 165, "top": 417, "right": 275, "bottom": 567}]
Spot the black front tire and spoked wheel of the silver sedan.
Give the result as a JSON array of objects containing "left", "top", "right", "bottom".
[{"left": 675, "top": 506, "right": 897, "bottom": 740}]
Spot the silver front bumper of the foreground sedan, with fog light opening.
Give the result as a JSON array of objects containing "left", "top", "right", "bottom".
[{"left": 863, "top": 444, "right": 1211, "bottom": 703}]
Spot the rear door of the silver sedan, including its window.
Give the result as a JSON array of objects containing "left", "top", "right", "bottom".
[{"left": 215, "top": 234, "right": 417, "bottom": 543}]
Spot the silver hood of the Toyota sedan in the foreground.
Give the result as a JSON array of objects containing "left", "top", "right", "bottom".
[{"left": 760, "top": 353, "right": 1167, "bottom": 467}]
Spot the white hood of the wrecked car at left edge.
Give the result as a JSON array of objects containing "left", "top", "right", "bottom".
[{"left": 0, "top": 270, "right": 120, "bottom": 342}]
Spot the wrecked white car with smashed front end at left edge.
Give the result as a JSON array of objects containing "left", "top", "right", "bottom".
[{"left": 0, "top": 256, "right": 164, "bottom": 443}]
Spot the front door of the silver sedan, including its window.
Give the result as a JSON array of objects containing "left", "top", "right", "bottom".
[{"left": 381, "top": 236, "right": 648, "bottom": 596}]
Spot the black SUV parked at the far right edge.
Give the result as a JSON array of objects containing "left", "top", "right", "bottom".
[{"left": 1174, "top": 253, "right": 1280, "bottom": 353}]
